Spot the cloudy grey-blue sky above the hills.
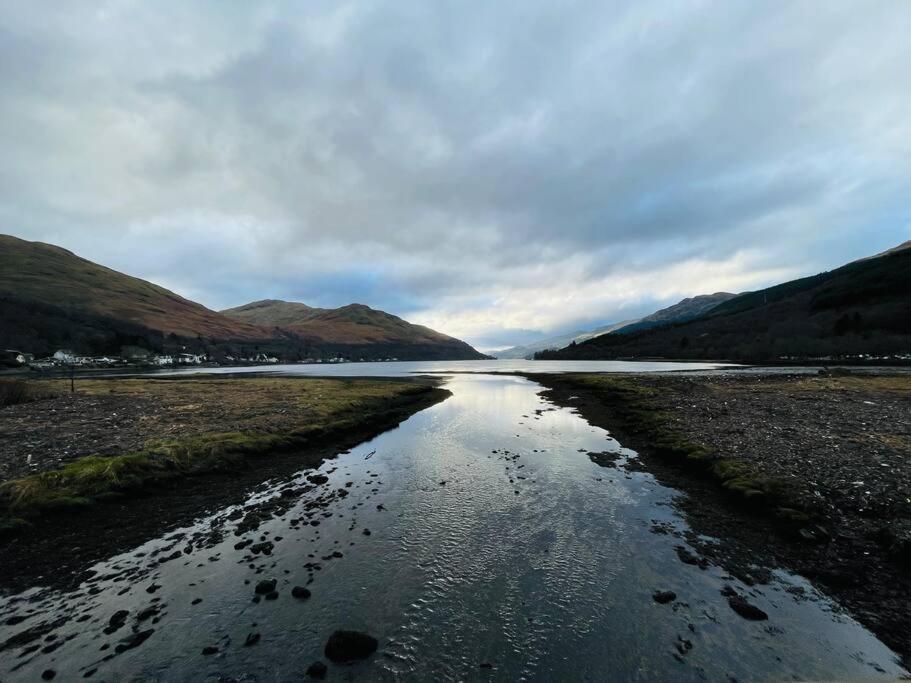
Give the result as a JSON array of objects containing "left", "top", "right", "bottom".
[{"left": 0, "top": 0, "right": 911, "bottom": 350}]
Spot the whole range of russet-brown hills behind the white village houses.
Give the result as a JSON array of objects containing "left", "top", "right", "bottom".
[{"left": 0, "top": 235, "right": 484, "bottom": 360}]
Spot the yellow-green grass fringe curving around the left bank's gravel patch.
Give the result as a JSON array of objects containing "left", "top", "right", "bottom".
[{"left": 0, "top": 379, "right": 448, "bottom": 531}]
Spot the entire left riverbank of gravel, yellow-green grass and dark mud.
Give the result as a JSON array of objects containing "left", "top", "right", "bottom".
[{"left": 0, "top": 377, "right": 449, "bottom": 584}]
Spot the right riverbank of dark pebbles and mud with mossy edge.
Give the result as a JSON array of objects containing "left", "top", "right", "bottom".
[{"left": 532, "top": 373, "right": 911, "bottom": 664}]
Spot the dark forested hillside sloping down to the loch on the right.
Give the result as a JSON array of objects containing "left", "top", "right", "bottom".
[{"left": 536, "top": 243, "right": 911, "bottom": 362}]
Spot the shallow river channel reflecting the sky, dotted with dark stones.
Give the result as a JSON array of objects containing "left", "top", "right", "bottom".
[{"left": 0, "top": 376, "right": 902, "bottom": 681}]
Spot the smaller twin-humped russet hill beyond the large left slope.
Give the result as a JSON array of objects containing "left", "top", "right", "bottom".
[{"left": 222, "top": 299, "right": 485, "bottom": 360}]
